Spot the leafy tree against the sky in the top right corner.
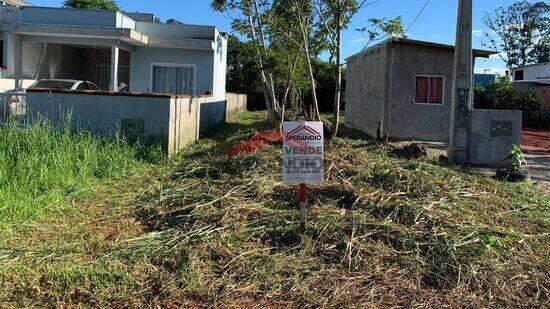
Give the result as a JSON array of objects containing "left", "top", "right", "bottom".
[{"left": 483, "top": 0, "right": 550, "bottom": 68}]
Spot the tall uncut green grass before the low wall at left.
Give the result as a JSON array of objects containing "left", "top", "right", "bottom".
[{"left": 0, "top": 122, "right": 153, "bottom": 227}]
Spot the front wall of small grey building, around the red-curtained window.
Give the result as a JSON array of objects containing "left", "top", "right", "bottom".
[{"left": 385, "top": 44, "right": 454, "bottom": 142}]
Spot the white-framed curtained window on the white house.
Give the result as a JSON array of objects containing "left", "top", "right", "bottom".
[{"left": 152, "top": 64, "right": 195, "bottom": 95}]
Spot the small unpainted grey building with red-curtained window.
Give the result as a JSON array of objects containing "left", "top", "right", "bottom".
[{"left": 345, "top": 39, "right": 495, "bottom": 142}]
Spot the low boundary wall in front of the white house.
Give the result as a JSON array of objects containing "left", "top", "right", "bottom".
[{"left": 0, "top": 89, "right": 246, "bottom": 155}]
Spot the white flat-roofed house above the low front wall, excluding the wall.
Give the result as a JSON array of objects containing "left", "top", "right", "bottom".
[{"left": 0, "top": 1, "right": 227, "bottom": 100}]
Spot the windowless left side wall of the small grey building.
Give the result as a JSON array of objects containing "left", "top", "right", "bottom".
[{"left": 344, "top": 45, "right": 388, "bottom": 136}]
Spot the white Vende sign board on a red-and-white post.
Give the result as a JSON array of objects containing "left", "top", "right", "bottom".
[{"left": 283, "top": 121, "right": 324, "bottom": 184}]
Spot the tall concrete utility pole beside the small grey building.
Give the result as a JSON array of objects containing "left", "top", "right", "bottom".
[{"left": 447, "top": 0, "right": 473, "bottom": 163}]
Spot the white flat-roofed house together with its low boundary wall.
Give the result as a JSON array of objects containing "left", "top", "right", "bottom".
[{"left": 0, "top": 5, "right": 246, "bottom": 158}]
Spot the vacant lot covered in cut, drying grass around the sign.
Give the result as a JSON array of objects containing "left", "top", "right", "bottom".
[{"left": 0, "top": 113, "right": 550, "bottom": 308}]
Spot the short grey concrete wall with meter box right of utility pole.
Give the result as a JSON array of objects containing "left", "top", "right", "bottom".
[{"left": 469, "top": 109, "right": 522, "bottom": 166}]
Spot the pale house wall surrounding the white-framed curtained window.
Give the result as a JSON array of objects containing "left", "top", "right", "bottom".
[{"left": 130, "top": 47, "right": 214, "bottom": 95}]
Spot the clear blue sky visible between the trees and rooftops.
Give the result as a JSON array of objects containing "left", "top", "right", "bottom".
[{"left": 28, "top": 0, "right": 532, "bottom": 73}]
